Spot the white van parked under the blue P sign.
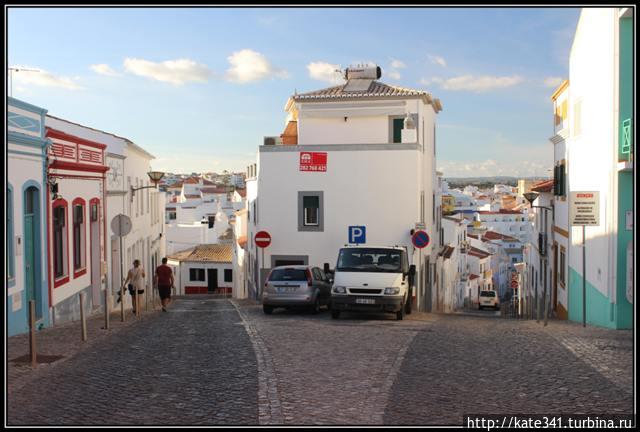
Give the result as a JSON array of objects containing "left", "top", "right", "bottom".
[{"left": 325, "top": 246, "right": 415, "bottom": 320}]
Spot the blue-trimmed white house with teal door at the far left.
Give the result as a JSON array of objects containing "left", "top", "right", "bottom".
[{"left": 5, "top": 97, "right": 50, "bottom": 336}]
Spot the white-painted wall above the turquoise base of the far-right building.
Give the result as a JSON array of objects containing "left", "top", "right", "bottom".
[{"left": 567, "top": 8, "right": 618, "bottom": 298}]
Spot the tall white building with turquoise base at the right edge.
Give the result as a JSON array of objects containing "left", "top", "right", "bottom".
[{"left": 555, "top": 7, "right": 635, "bottom": 329}]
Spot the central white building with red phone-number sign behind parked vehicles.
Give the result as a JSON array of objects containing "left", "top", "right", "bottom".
[{"left": 245, "top": 68, "right": 442, "bottom": 309}]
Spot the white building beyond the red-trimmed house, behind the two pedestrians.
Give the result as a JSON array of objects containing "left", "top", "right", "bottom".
[{"left": 47, "top": 116, "right": 166, "bottom": 316}]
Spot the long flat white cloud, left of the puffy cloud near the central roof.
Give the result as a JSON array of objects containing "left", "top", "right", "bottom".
[{"left": 124, "top": 58, "right": 213, "bottom": 85}]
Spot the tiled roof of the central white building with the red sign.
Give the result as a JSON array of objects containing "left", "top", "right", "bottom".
[{"left": 291, "top": 81, "right": 442, "bottom": 112}]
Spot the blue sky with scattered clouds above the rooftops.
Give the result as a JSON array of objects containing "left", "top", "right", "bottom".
[{"left": 7, "top": 8, "right": 580, "bottom": 177}]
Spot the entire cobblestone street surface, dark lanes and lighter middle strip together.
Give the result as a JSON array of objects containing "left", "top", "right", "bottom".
[{"left": 8, "top": 296, "right": 633, "bottom": 425}]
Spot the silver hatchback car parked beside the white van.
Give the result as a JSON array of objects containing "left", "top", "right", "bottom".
[{"left": 262, "top": 265, "right": 331, "bottom": 314}]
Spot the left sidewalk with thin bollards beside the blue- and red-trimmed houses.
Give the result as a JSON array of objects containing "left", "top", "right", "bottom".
[{"left": 7, "top": 303, "right": 161, "bottom": 395}]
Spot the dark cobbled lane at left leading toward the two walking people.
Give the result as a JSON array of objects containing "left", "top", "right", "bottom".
[{"left": 7, "top": 299, "right": 258, "bottom": 425}]
